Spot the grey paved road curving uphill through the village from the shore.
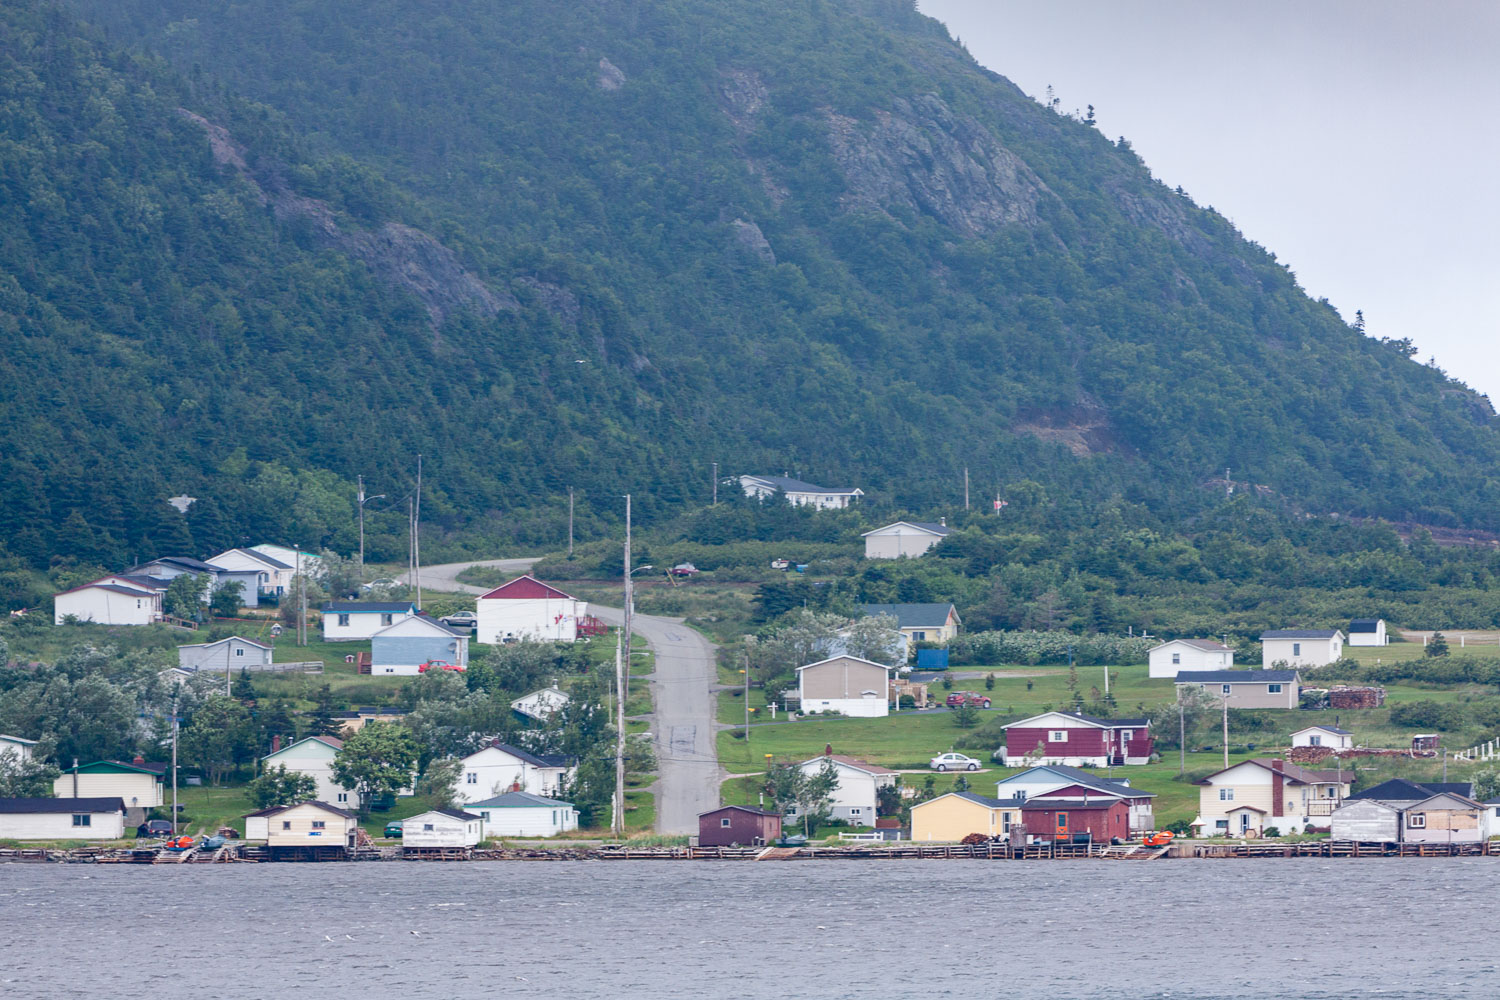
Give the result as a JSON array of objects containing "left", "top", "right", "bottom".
[{"left": 408, "top": 559, "right": 722, "bottom": 834}]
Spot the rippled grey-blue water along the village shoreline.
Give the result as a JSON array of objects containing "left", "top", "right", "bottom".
[{"left": 0, "top": 858, "right": 1500, "bottom": 1000}]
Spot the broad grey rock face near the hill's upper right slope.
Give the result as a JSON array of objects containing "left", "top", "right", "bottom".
[{"left": 824, "top": 94, "right": 1047, "bottom": 235}]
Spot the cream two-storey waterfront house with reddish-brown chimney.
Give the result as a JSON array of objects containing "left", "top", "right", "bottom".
[{"left": 1193, "top": 757, "right": 1355, "bottom": 837}]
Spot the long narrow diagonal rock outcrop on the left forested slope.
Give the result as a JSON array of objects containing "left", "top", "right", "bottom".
[{"left": 179, "top": 108, "right": 521, "bottom": 328}]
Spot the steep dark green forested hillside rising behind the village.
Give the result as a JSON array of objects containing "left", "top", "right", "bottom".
[{"left": 0, "top": 0, "right": 1500, "bottom": 578}]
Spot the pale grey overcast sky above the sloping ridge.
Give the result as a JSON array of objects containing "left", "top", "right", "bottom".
[{"left": 920, "top": 0, "right": 1500, "bottom": 403}]
